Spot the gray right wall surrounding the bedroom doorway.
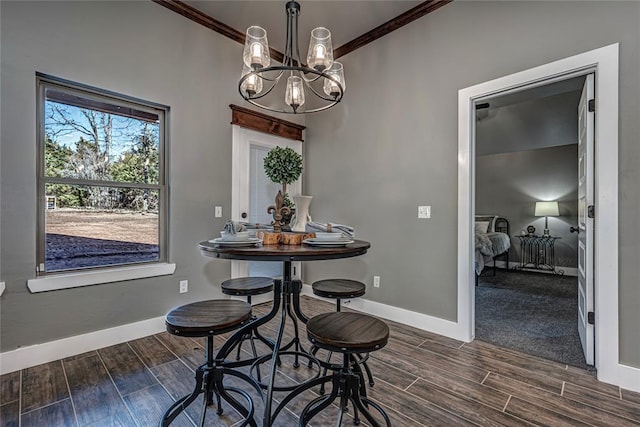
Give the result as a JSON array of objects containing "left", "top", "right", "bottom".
[{"left": 305, "top": 1, "right": 640, "bottom": 367}]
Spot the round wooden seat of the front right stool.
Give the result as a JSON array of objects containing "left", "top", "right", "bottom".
[{"left": 307, "top": 312, "right": 389, "bottom": 353}]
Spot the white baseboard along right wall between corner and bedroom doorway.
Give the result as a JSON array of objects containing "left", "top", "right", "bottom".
[{"left": 302, "top": 285, "right": 462, "bottom": 341}]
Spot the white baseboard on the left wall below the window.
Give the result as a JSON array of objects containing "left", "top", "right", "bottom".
[{"left": 0, "top": 316, "right": 166, "bottom": 375}]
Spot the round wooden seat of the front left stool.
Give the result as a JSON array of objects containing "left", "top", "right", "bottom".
[{"left": 165, "top": 299, "right": 251, "bottom": 337}]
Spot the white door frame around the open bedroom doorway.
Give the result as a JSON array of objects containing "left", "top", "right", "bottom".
[{"left": 457, "top": 43, "right": 622, "bottom": 384}]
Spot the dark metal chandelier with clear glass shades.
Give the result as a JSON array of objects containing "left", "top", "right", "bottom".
[{"left": 238, "top": 1, "right": 345, "bottom": 114}]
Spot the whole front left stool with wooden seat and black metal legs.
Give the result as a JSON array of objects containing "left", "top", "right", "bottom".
[{"left": 160, "top": 299, "right": 259, "bottom": 427}]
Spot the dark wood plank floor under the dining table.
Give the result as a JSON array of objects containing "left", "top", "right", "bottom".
[{"left": 0, "top": 297, "right": 640, "bottom": 427}]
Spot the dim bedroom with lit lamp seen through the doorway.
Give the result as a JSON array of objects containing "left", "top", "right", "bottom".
[{"left": 474, "top": 75, "right": 592, "bottom": 369}]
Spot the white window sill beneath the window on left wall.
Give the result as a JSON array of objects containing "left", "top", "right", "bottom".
[{"left": 27, "top": 263, "right": 176, "bottom": 293}]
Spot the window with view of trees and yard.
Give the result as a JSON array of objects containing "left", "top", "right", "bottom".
[{"left": 37, "top": 74, "right": 168, "bottom": 275}]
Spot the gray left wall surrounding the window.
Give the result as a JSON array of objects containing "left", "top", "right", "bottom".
[{"left": 0, "top": 1, "right": 270, "bottom": 351}]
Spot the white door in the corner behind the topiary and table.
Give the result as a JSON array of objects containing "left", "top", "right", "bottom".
[{"left": 231, "top": 125, "right": 302, "bottom": 303}]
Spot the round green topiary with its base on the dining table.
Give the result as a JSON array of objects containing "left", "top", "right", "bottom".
[{"left": 264, "top": 147, "right": 302, "bottom": 231}]
